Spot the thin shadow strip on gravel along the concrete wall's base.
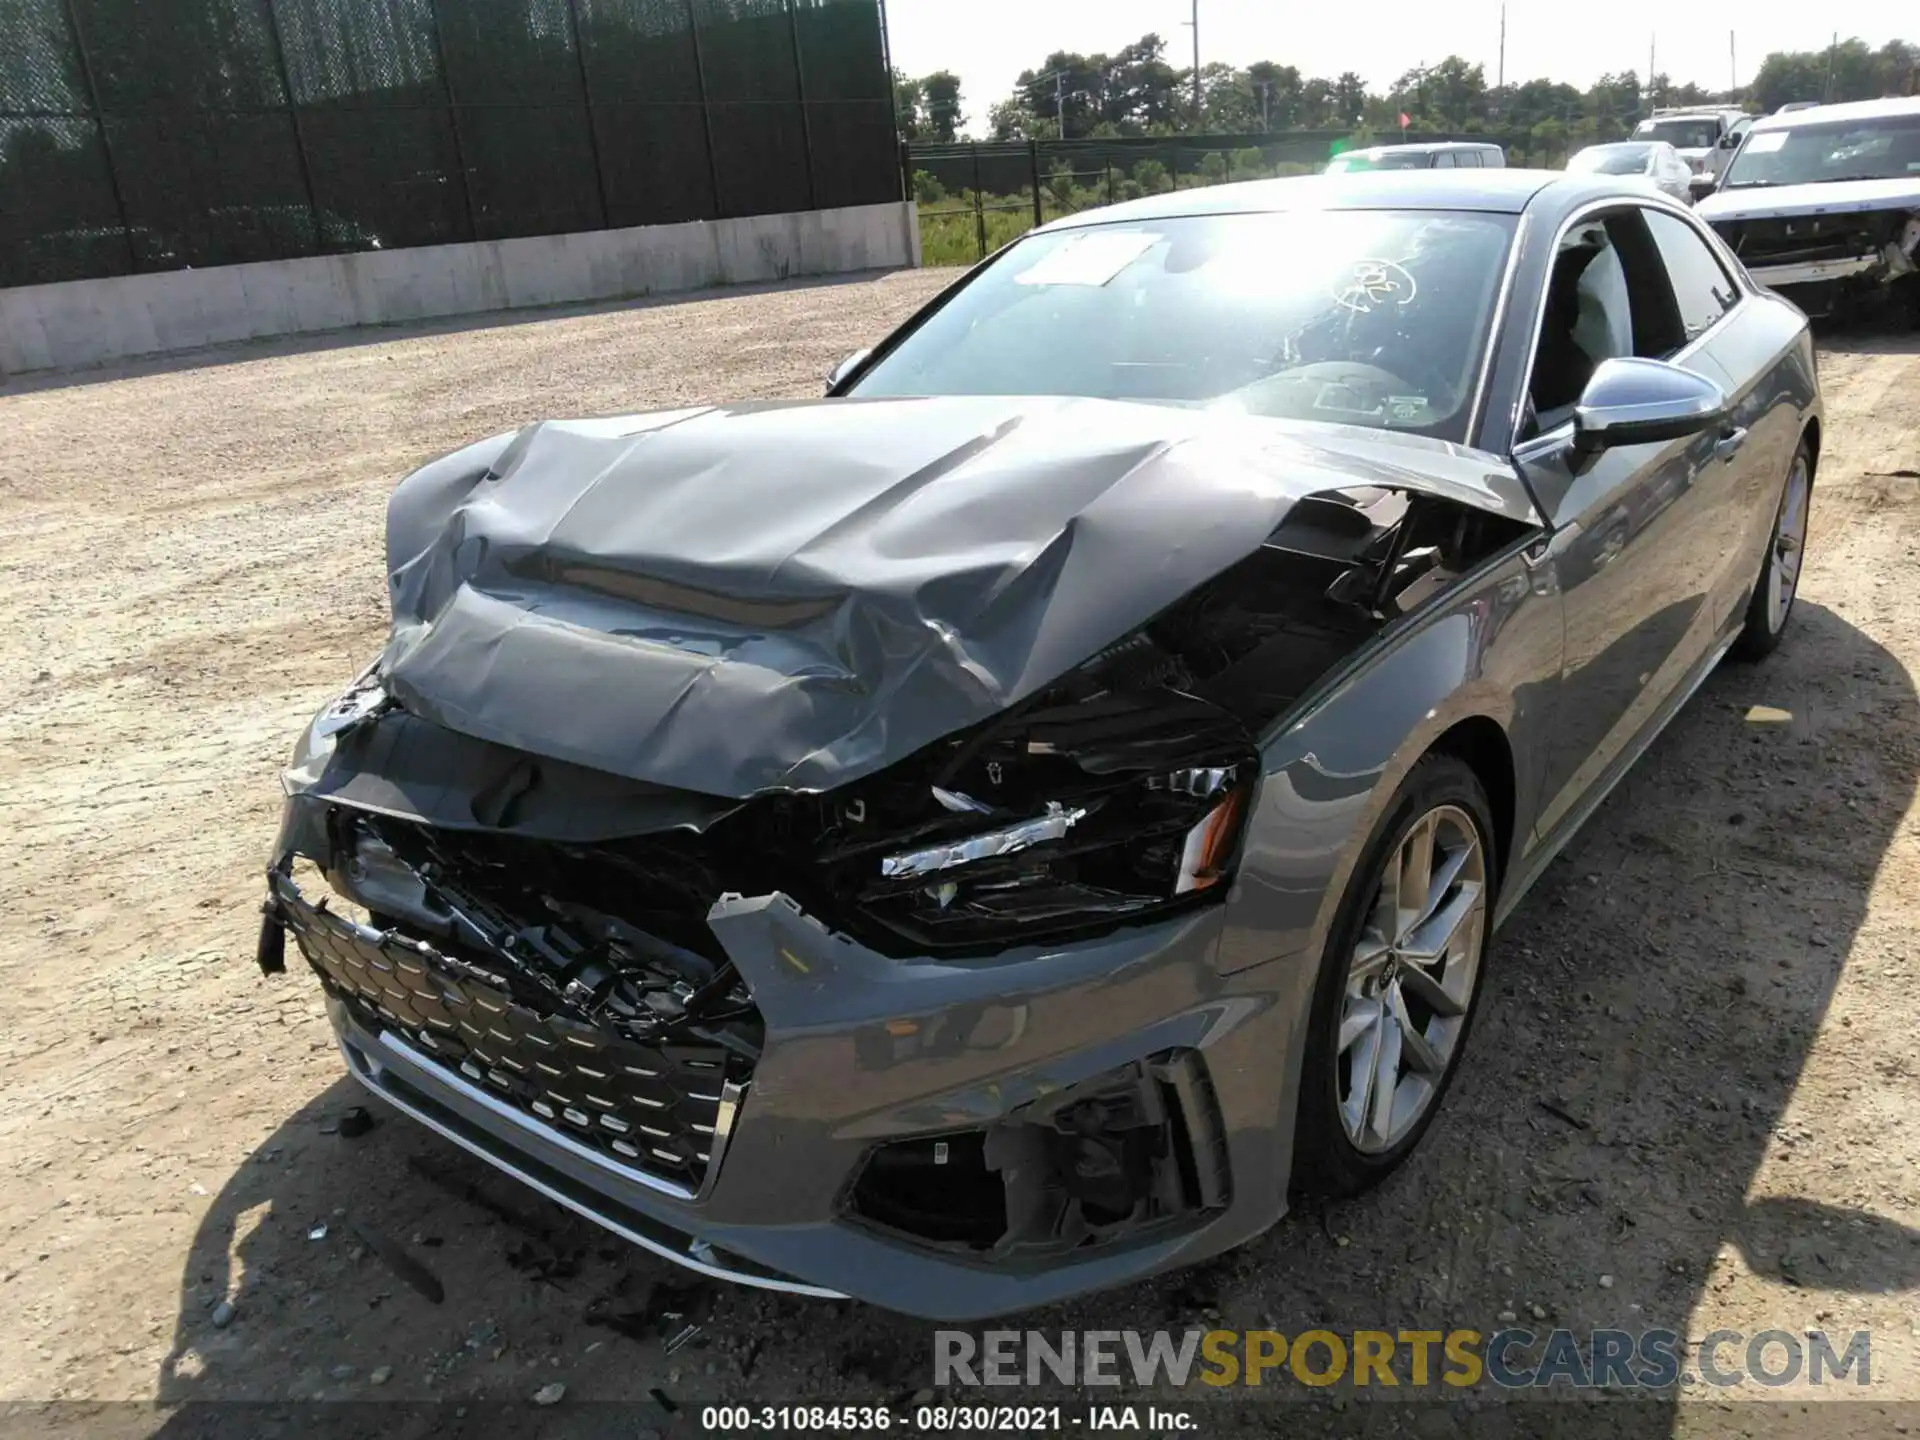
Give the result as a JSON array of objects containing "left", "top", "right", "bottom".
[{"left": 0, "top": 271, "right": 917, "bottom": 396}]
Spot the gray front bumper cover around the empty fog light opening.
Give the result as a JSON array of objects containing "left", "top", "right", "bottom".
[{"left": 282, "top": 864, "right": 1311, "bottom": 1321}]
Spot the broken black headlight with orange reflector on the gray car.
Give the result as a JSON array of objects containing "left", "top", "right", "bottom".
[{"left": 798, "top": 691, "right": 1258, "bottom": 952}]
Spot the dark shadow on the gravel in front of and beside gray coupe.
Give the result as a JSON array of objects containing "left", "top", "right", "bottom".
[{"left": 157, "top": 599, "right": 1920, "bottom": 1436}]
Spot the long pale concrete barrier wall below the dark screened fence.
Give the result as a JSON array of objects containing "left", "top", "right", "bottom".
[{"left": 0, "top": 202, "right": 920, "bottom": 374}]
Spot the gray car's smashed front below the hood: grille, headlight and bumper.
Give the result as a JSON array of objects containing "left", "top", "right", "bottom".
[{"left": 261, "top": 672, "right": 1271, "bottom": 1315}]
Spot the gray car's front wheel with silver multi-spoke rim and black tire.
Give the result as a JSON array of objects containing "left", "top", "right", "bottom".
[{"left": 1294, "top": 755, "right": 1500, "bottom": 1196}]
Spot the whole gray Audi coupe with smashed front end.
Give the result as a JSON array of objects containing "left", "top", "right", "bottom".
[{"left": 259, "top": 171, "right": 1820, "bottom": 1319}]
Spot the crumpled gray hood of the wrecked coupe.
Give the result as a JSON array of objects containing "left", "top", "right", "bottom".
[{"left": 380, "top": 397, "right": 1532, "bottom": 799}]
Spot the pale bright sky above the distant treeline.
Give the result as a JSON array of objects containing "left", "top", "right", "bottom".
[{"left": 887, "top": 0, "right": 1920, "bottom": 131}]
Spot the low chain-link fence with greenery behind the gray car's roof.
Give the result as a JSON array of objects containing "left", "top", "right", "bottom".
[{"left": 902, "top": 131, "right": 1567, "bottom": 265}]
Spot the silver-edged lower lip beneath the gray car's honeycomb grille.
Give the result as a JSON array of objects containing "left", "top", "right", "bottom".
[{"left": 340, "top": 1031, "right": 847, "bottom": 1300}]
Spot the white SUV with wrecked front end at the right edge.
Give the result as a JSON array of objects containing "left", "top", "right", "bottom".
[{"left": 1699, "top": 98, "right": 1920, "bottom": 319}]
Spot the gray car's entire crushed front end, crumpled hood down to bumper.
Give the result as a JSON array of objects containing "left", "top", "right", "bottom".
[{"left": 259, "top": 397, "right": 1532, "bottom": 1319}]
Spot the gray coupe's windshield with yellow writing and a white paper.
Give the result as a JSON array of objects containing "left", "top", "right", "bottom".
[{"left": 847, "top": 209, "right": 1515, "bottom": 440}]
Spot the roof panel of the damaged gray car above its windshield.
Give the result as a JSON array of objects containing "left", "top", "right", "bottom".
[{"left": 1043, "top": 169, "right": 1645, "bottom": 230}]
